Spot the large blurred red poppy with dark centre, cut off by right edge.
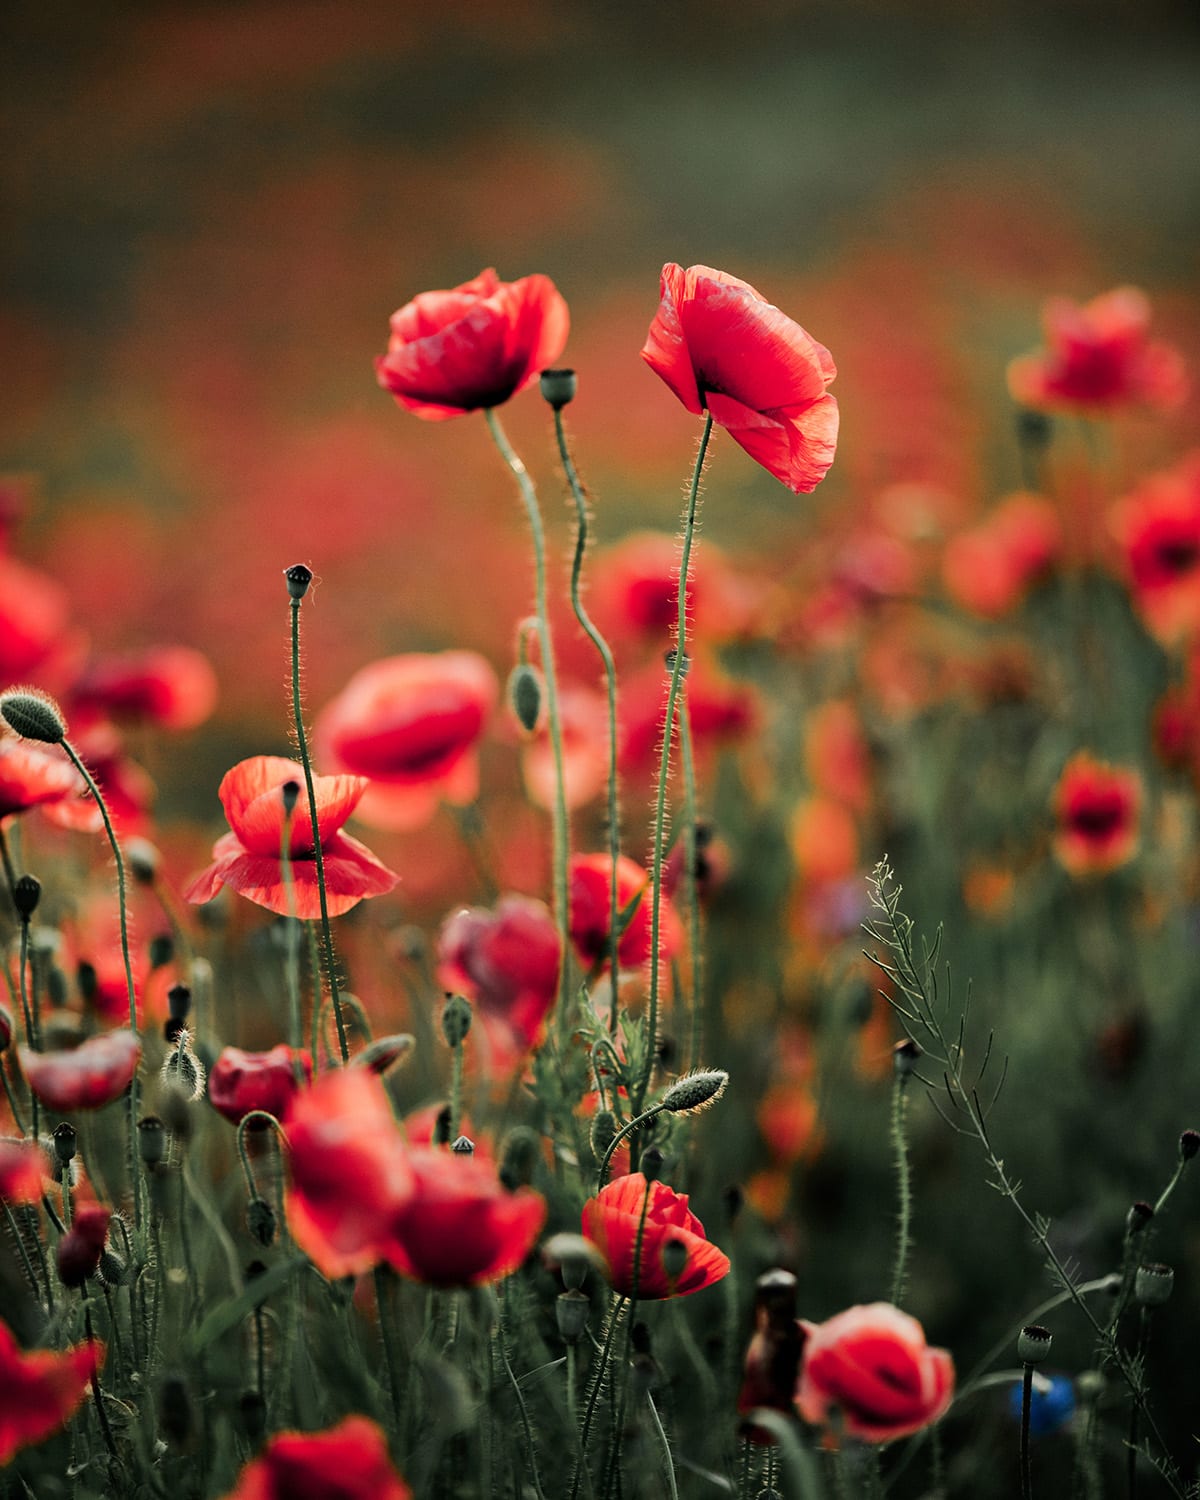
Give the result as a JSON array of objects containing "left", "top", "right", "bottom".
[{"left": 1110, "top": 452, "right": 1200, "bottom": 645}]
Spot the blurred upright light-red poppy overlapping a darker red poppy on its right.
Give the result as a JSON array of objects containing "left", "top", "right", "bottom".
[{"left": 285, "top": 1068, "right": 414, "bottom": 1278}]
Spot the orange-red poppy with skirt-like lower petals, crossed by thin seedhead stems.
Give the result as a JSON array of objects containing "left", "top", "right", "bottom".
[{"left": 183, "top": 755, "right": 399, "bottom": 921}]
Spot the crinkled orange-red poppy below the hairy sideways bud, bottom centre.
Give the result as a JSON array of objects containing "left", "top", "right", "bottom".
[{"left": 584, "top": 1172, "right": 729, "bottom": 1301}]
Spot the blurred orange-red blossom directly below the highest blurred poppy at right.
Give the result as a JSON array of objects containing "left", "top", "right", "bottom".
[{"left": 942, "top": 494, "right": 1062, "bottom": 620}]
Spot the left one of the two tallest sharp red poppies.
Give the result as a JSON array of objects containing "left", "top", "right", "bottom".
[{"left": 375, "top": 270, "right": 570, "bottom": 422}]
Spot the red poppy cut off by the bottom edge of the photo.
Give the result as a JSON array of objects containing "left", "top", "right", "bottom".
[{"left": 225, "top": 1416, "right": 413, "bottom": 1500}]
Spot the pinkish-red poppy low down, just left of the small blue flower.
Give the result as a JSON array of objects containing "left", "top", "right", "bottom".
[{"left": 797, "top": 1302, "right": 954, "bottom": 1443}]
